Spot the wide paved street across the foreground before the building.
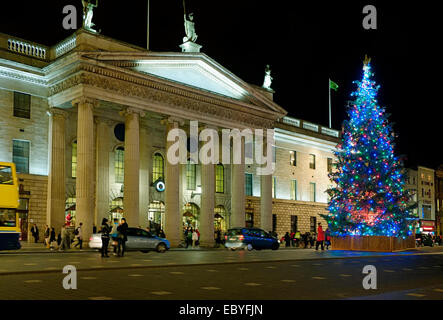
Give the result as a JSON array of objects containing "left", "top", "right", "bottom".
[{"left": 0, "top": 249, "right": 443, "bottom": 300}]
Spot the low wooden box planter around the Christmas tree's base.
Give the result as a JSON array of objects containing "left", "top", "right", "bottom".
[{"left": 331, "top": 236, "right": 415, "bottom": 252}]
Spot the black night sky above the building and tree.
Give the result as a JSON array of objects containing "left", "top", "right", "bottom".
[{"left": 0, "top": 0, "right": 443, "bottom": 168}]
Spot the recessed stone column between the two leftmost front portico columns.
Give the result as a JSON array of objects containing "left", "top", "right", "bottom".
[{"left": 94, "top": 118, "right": 113, "bottom": 230}]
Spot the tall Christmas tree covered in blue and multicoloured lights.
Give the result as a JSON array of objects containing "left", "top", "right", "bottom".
[{"left": 322, "top": 57, "right": 417, "bottom": 238}]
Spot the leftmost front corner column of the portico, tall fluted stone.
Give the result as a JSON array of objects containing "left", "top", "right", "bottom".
[{"left": 72, "top": 97, "right": 98, "bottom": 241}]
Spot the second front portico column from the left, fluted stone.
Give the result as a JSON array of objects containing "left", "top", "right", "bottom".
[{"left": 122, "top": 108, "right": 144, "bottom": 227}]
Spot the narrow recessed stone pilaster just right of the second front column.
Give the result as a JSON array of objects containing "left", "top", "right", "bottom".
[{"left": 139, "top": 127, "right": 151, "bottom": 228}]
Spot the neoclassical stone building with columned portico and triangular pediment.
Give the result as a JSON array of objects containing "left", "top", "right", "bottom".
[{"left": 0, "top": 29, "right": 339, "bottom": 245}]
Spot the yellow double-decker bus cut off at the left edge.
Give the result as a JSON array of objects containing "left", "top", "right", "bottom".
[{"left": 0, "top": 162, "right": 21, "bottom": 250}]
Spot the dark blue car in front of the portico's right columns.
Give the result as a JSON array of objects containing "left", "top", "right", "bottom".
[{"left": 225, "top": 228, "right": 280, "bottom": 251}]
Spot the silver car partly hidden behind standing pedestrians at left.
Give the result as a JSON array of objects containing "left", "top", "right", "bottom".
[{"left": 89, "top": 228, "right": 171, "bottom": 253}]
